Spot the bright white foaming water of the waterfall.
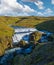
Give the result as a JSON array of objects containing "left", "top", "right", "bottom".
[{"left": 12, "top": 27, "right": 37, "bottom": 44}]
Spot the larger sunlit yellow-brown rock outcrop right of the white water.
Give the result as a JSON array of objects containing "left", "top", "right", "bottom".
[{"left": 29, "top": 31, "right": 42, "bottom": 44}]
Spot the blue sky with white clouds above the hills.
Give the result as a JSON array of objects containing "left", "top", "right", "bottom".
[{"left": 0, "top": 0, "right": 54, "bottom": 16}]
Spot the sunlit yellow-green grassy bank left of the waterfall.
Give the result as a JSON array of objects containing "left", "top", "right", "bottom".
[{"left": 0, "top": 16, "right": 13, "bottom": 56}]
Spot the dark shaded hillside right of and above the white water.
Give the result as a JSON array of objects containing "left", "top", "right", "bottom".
[{"left": 35, "top": 20, "right": 54, "bottom": 33}]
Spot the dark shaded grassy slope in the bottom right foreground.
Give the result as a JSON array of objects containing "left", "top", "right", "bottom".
[{"left": 12, "top": 42, "right": 54, "bottom": 65}]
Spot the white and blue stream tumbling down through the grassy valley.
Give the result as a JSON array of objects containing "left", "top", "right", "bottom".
[{"left": 0, "top": 26, "right": 51, "bottom": 65}]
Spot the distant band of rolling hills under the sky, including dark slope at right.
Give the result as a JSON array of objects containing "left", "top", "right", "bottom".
[{"left": 0, "top": 16, "right": 54, "bottom": 32}]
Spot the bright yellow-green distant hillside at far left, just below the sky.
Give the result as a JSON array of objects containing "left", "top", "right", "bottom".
[{"left": 0, "top": 16, "right": 19, "bottom": 26}]
